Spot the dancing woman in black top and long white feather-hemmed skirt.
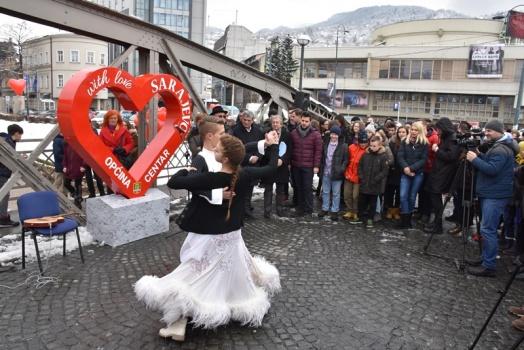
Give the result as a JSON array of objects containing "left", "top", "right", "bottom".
[{"left": 135, "top": 135, "right": 280, "bottom": 341}]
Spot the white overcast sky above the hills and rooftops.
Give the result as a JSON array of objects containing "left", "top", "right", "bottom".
[{"left": 0, "top": 0, "right": 524, "bottom": 35}]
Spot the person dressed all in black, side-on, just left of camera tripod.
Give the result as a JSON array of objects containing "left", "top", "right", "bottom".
[{"left": 424, "top": 117, "right": 460, "bottom": 234}]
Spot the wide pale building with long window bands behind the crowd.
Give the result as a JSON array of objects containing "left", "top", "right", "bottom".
[{"left": 292, "top": 19, "right": 524, "bottom": 125}]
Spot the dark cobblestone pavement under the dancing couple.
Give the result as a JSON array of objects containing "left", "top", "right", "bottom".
[{"left": 0, "top": 198, "right": 524, "bottom": 350}]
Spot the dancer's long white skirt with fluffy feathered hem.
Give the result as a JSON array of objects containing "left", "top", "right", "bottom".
[{"left": 135, "top": 230, "right": 280, "bottom": 328}]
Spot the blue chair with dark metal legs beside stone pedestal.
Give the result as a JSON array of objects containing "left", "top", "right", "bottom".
[{"left": 17, "top": 191, "right": 84, "bottom": 273}]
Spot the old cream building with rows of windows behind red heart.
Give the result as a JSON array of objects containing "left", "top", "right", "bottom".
[{"left": 23, "top": 34, "right": 108, "bottom": 111}]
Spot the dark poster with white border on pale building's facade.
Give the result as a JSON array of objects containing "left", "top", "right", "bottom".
[{"left": 468, "top": 45, "right": 504, "bottom": 78}]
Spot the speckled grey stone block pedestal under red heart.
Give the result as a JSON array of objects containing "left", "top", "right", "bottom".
[{"left": 86, "top": 188, "right": 169, "bottom": 247}]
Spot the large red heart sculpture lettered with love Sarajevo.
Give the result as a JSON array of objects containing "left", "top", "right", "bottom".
[{"left": 57, "top": 67, "right": 191, "bottom": 198}]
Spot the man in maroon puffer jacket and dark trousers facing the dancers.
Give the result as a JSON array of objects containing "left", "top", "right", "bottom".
[{"left": 291, "top": 112, "right": 322, "bottom": 216}]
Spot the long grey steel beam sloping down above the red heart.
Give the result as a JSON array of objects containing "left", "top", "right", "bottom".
[{"left": 0, "top": 0, "right": 296, "bottom": 104}]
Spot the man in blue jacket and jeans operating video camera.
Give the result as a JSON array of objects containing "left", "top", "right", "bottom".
[{"left": 466, "top": 119, "right": 515, "bottom": 277}]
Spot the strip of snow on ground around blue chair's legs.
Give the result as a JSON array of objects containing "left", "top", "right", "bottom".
[{"left": 0, "top": 227, "right": 95, "bottom": 265}]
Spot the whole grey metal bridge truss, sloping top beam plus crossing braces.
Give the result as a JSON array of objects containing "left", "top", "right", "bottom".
[{"left": 0, "top": 0, "right": 334, "bottom": 213}]
